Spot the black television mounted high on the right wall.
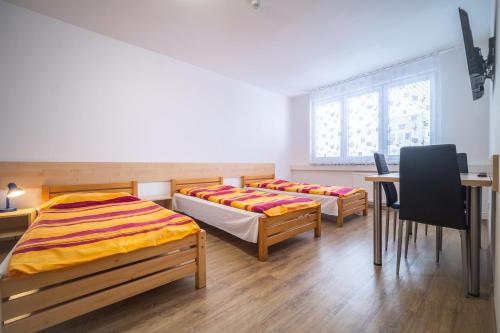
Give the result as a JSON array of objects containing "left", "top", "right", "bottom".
[{"left": 458, "top": 8, "right": 495, "bottom": 100}]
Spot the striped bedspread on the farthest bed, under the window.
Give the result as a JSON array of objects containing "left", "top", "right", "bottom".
[{"left": 249, "top": 179, "right": 365, "bottom": 197}]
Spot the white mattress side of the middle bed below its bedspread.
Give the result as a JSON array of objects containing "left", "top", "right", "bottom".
[{"left": 172, "top": 193, "right": 265, "bottom": 243}]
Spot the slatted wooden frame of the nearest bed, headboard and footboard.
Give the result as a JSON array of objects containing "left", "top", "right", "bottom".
[{"left": 0, "top": 182, "right": 206, "bottom": 333}]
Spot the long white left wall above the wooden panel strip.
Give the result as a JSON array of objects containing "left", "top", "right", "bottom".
[{"left": 0, "top": 0, "right": 290, "bottom": 206}]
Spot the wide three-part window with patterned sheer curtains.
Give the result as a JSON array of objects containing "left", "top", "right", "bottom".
[{"left": 311, "top": 56, "right": 436, "bottom": 164}]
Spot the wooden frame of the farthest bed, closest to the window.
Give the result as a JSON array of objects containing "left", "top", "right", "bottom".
[{"left": 241, "top": 175, "right": 368, "bottom": 227}]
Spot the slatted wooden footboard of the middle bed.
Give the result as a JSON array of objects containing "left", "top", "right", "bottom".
[{"left": 258, "top": 206, "right": 321, "bottom": 261}]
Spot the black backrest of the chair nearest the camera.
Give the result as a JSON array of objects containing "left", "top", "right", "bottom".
[{"left": 399, "top": 145, "right": 467, "bottom": 229}]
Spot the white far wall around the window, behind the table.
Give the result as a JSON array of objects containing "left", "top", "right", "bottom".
[{"left": 290, "top": 43, "right": 490, "bottom": 205}]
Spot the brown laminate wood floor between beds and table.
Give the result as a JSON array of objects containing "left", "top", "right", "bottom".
[{"left": 41, "top": 211, "right": 495, "bottom": 333}]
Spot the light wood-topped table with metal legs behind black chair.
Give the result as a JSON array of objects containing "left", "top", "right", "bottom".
[{"left": 365, "top": 173, "right": 492, "bottom": 296}]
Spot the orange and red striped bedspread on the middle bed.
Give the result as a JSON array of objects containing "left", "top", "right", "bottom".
[{"left": 180, "top": 185, "right": 320, "bottom": 216}]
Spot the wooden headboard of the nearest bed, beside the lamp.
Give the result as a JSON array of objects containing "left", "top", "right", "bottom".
[{"left": 42, "top": 181, "right": 137, "bottom": 202}]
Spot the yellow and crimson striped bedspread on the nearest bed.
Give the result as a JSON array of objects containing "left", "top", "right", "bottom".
[{"left": 7, "top": 193, "right": 200, "bottom": 276}]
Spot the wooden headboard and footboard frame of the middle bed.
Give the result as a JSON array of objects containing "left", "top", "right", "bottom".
[{"left": 171, "top": 177, "right": 321, "bottom": 261}]
